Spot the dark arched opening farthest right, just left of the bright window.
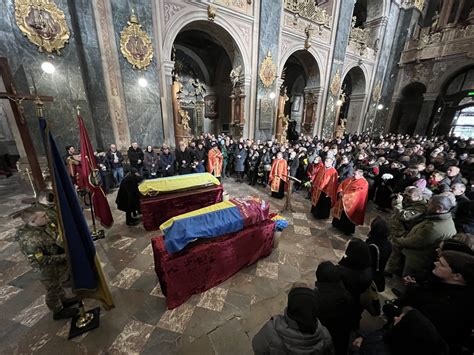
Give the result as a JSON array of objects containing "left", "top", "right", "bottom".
[{"left": 390, "top": 82, "right": 426, "bottom": 135}]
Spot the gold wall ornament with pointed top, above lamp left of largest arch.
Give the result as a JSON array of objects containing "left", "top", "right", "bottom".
[{"left": 120, "top": 10, "right": 153, "bottom": 69}]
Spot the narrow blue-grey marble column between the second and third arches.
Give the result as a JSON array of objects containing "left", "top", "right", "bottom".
[{"left": 322, "top": 1, "right": 354, "bottom": 138}]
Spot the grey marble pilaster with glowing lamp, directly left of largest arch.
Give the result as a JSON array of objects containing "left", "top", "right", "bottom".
[{"left": 111, "top": 0, "right": 163, "bottom": 146}]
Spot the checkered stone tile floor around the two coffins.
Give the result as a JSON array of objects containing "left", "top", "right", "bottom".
[{"left": 0, "top": 176, "right": 392, "bottom": 355}]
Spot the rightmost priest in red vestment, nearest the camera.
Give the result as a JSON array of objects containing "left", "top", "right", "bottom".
[{"left": 332, "top": 169, "right": 369, "bottom": 235}]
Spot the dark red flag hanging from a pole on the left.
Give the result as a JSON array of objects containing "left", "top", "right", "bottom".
[{"left": 77, "top": 115, "right": 114, "bottom": 228}]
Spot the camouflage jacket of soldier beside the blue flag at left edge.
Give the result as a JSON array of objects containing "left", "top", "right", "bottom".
[{"left": 15, "top": 224, "right": 66, "bottom": 269}]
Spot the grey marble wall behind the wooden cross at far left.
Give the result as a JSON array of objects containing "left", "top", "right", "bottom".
[{"left": 0, "top": 0, "right": 100, "bottom": 154}]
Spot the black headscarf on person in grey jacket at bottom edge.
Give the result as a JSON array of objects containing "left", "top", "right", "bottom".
[{"left": 286, "top": 287, "right": 319, "bottom": 334}]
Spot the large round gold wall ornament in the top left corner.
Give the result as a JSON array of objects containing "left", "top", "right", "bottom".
[{"left": 15, "top": 0, "right": 70, "bottom": 54}]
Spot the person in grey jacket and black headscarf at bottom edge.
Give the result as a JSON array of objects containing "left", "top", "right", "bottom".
[{"left": 252, "top": 287, "right": 334, "bottom": 355}]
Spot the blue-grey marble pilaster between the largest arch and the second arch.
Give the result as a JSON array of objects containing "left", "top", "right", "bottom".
[{"left": 255, "top": 0, "right": 283, "bottom": 140}]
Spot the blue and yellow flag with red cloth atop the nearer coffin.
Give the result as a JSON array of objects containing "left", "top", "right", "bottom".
[{"left": 160, "top": 199, "right": 269, "bottom": 254}]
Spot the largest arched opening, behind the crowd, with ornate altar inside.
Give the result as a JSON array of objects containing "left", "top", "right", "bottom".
[{"left": 171, "top": 21, "right": 245, "bottom": 136}]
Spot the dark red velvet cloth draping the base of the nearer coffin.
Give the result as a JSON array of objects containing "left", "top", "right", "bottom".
[{"left": 151, "top": 220, "right": 275, "bottom": 309}]
